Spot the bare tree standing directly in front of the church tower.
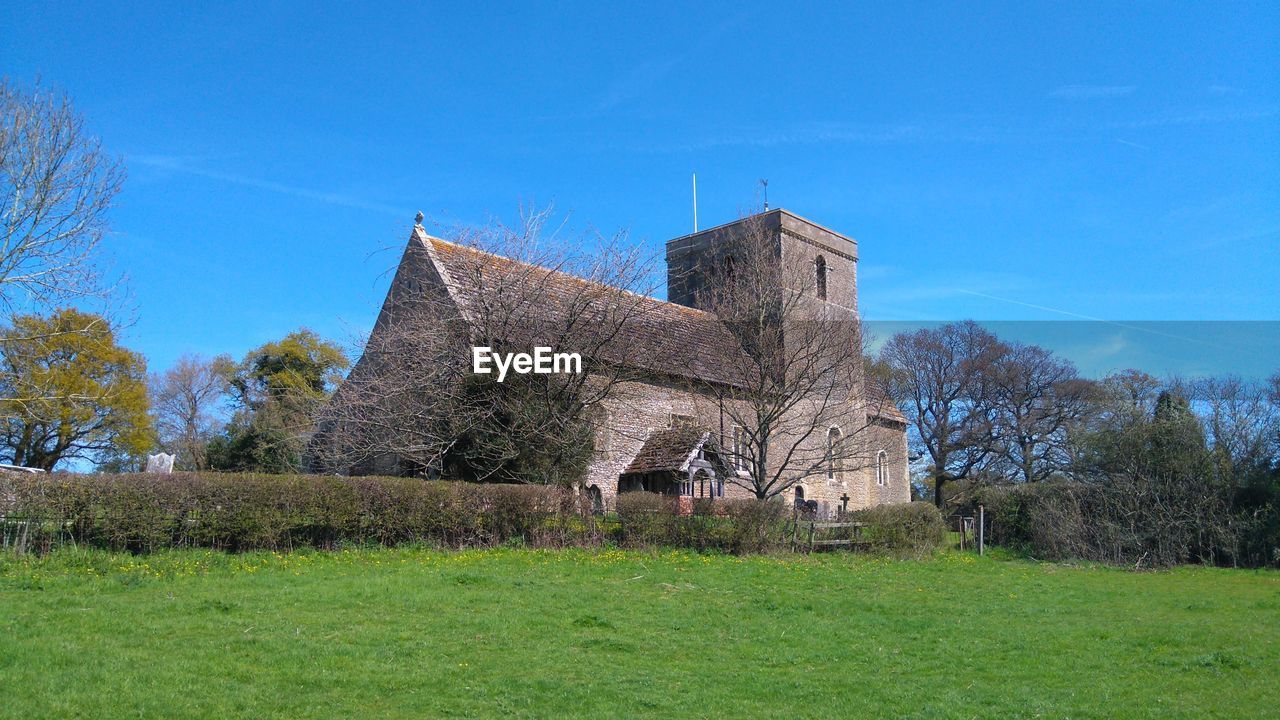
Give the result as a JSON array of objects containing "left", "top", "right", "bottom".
[{"left": 692, "top": 210, "right": 886, "bottom": 500}]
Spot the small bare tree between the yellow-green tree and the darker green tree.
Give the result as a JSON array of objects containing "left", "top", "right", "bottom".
[{"left": 148, "top": 355, "right": 233, "bottom": 470}]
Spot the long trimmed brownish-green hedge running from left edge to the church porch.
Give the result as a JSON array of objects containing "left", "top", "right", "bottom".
[{"left": 0, "top": 473, "right": 602, "bottom": 552}]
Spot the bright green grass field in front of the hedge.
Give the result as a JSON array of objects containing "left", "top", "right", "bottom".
[{"left": 0, "top": 548, "right": 1280, "bottom": 719}]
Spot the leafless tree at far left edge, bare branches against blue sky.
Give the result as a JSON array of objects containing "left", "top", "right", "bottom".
[{"left": 0, "top": 79, "right": 124, "bottom": 311}]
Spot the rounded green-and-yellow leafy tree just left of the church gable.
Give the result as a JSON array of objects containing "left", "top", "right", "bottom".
[{"left": 207, "top": 328, "right": 351, "bottom": 473}]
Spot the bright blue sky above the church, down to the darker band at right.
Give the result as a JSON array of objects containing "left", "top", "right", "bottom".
[{"left": 0, "top": 1, "right": 1280, "bottom": 369}]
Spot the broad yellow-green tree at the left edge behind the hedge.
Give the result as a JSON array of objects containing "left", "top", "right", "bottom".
[{"left": 0, "top": 309, "right": 155, "bottom": 470}]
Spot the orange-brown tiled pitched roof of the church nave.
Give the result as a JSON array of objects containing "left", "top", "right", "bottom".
[{"left": 419, "top": 233, "right": 742, "bottom": 384}]
